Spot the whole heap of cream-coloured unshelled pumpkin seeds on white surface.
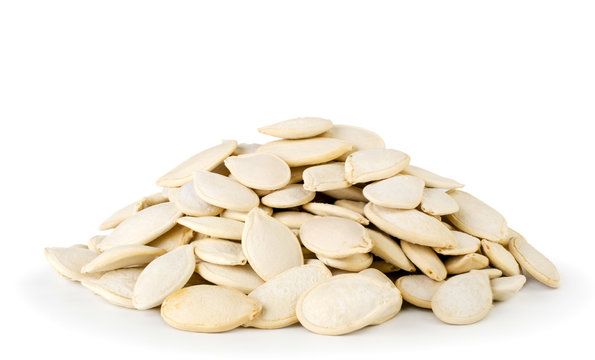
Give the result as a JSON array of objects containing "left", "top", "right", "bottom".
[{"left": 45, "top": 118, "right": 560, "bottom": 335}]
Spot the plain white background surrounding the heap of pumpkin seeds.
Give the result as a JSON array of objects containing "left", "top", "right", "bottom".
[{"left": 0, "top": 0, "right": 595, "bottom": 359}]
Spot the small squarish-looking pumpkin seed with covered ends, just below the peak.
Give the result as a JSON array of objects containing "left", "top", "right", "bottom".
[{"left": 302, "top": 162, "right": 351, "bottom": 191}]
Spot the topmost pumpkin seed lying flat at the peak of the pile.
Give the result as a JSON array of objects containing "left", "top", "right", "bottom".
[{"left": 258, "top": 117, "right": 333, "bottom": 139}]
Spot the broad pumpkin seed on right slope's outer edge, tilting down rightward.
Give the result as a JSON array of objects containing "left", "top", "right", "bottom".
[{"left": 447, "top": 190, "right": 508, "bottom": 241}]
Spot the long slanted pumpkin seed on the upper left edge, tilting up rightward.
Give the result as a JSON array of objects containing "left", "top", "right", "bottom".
[{"left": 157, "top": 140, "right": 238, "bottom": 187}]
